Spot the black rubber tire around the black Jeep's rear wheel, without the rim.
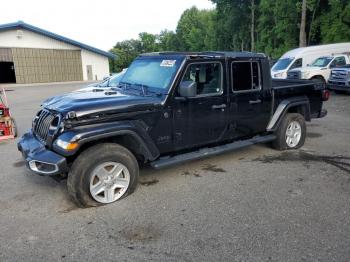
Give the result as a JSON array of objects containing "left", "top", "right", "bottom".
[{"left": 272, "top": 113, "right": 306, "bottom": 150}]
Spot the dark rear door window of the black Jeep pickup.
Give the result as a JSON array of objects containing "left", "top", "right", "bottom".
[{"left": 231, "top": 62, "right": 261, "bottom": 92}]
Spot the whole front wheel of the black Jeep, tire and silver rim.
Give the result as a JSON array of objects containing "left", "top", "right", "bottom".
[{"left": 67, "top": 143, "right": 139, "bottom": 207}]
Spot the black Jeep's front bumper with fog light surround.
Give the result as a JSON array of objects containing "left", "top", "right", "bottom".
[{"left": 17, "top": 131, "right": 68, "bottom": 176}]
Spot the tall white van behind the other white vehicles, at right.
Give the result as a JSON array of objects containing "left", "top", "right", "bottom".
[{"left": 271, "top": 43, "right": 350, "bottom": 79}]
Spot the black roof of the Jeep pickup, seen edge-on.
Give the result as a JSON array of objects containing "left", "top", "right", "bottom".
[{"left": 141, "top": 51, "right": 266, "bottom": 58}]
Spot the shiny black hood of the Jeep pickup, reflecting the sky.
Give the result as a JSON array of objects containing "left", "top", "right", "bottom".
[{"left": 42, "top": 89, "right": 164, "bottom": 117}]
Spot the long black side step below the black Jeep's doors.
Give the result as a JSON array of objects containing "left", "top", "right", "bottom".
[{"left": 150, "top": 135, "right": 276, "bottom": 169}]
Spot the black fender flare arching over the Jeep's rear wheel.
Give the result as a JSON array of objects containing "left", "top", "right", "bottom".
[{"left": 266, "top": 96, "right": 311, "bottom": 131}]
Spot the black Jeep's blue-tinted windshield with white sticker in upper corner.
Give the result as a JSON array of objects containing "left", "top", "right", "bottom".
[{"left": 120, "top": 57, "right": 181, "bottom": 91}]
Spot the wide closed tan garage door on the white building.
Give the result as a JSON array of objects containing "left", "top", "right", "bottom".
[{"left": 12, "top": 48, "right": 83, "bottom": 84}]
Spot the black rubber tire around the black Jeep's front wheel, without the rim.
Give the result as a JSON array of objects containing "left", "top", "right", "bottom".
[{"left": 67, "top": 143, "right": 139, "bottom": 207}]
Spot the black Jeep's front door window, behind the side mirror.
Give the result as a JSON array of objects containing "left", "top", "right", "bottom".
[{"left": 182, "top": 62, "right": 222, "bottom": 96}]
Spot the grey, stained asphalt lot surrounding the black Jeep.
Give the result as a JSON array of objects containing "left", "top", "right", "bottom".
[{"left": 0, "top": 83, "right": 350, "bottom": 262}]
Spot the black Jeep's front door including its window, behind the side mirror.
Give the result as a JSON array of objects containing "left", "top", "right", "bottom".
[{"left": 173, "top": 61, "right": 227, "bottom": 150}]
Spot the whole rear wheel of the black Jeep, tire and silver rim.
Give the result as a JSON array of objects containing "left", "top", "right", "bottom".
[{"left": 272, "top": 113, "right": 306, "bottom": 150}]
